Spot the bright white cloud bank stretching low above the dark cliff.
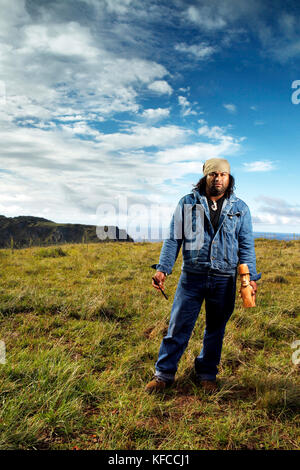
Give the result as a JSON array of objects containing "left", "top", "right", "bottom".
[{"left": 0, "top": 110, "right": 240, "bottom": 223}]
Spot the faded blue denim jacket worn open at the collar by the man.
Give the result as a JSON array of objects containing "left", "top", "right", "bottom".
[{"left": 151, "top": 189, "right": 261, "bottom": 281}]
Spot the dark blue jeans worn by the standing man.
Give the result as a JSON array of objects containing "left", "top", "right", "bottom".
[{"left": 155, "top": 271, "right": 236, "bottom": 382}]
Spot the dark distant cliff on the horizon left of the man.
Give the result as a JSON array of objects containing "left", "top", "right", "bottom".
[{"left": 0, "top": 215, "right": 134, "bottom": 248}]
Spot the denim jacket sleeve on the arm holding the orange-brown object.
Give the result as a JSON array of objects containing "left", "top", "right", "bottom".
[{"left": 238, "top": 206, "right": 261, "bottom": 281}]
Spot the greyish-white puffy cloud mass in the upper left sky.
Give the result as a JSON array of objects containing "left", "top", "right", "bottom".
[{"left": 0, "top": 5, "right": 171, "bottom": 126}]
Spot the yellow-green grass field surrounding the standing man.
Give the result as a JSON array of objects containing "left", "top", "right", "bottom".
[{"left": 0, "top": 239, "right": 300, "bottom": 450}]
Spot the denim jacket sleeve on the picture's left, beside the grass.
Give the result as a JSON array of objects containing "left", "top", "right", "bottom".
[{"left": 151, "top": 198, "right": 183, "bottom": 274}]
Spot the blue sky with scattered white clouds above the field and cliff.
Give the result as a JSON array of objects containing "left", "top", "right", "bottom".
[{"left": 0, "top": 0, "right": 300, "bottom": 238}]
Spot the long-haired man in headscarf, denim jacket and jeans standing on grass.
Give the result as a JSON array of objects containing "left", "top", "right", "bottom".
[{"left": 146, "top": 158, "right": 261, "bottom": 393}]
